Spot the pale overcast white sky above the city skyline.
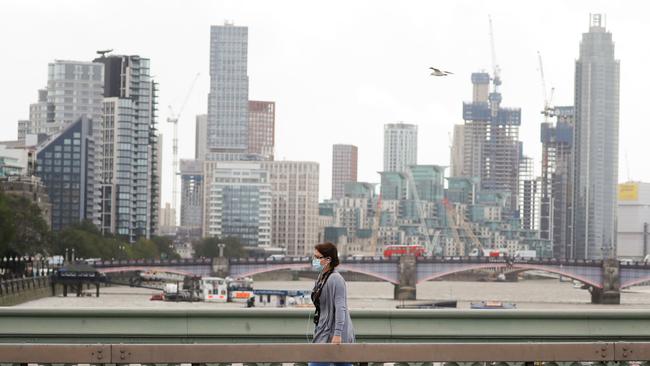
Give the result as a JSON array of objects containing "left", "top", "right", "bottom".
[{"left": 0, "top": 0, "right": 650, "bottom": 206}]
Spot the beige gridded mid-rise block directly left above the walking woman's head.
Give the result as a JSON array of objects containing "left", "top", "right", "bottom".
[{"left": 261, "top": 161, "right": 319, "bottom": 255}]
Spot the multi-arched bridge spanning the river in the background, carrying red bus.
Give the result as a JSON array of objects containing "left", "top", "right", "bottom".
[{"left": 87, "top": 256, "right": 650, "bottom": 304}]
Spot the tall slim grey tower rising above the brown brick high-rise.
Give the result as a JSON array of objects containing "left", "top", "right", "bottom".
[{"left": 207, "top": 23, "right": 248, "bottom": 154}]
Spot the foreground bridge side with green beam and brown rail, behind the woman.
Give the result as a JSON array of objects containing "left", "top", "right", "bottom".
[{"left": 0, "top": 308, "right": 650, "bottom": 366}]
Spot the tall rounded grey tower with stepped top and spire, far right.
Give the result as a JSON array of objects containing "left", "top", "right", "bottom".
[{"left": 573, "top": 14, "right": 620, "bottom": 259}]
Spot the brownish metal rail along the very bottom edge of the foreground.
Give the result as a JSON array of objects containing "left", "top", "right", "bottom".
[{"left": 0, "top": 342, "right": 650, "bottom": 366}]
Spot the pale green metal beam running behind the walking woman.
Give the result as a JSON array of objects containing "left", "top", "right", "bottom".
[{"left": 0, "top": 308, "right": 650, "bottom": 343}]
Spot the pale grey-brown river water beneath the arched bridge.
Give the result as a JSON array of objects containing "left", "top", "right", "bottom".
[{"left": 17, "top": 279, "right": 650, "bottom": 309}]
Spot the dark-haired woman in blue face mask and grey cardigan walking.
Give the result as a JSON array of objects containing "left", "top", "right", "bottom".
[{"left": 309, "top": 243, "right": 354, "bottom": 366}]
